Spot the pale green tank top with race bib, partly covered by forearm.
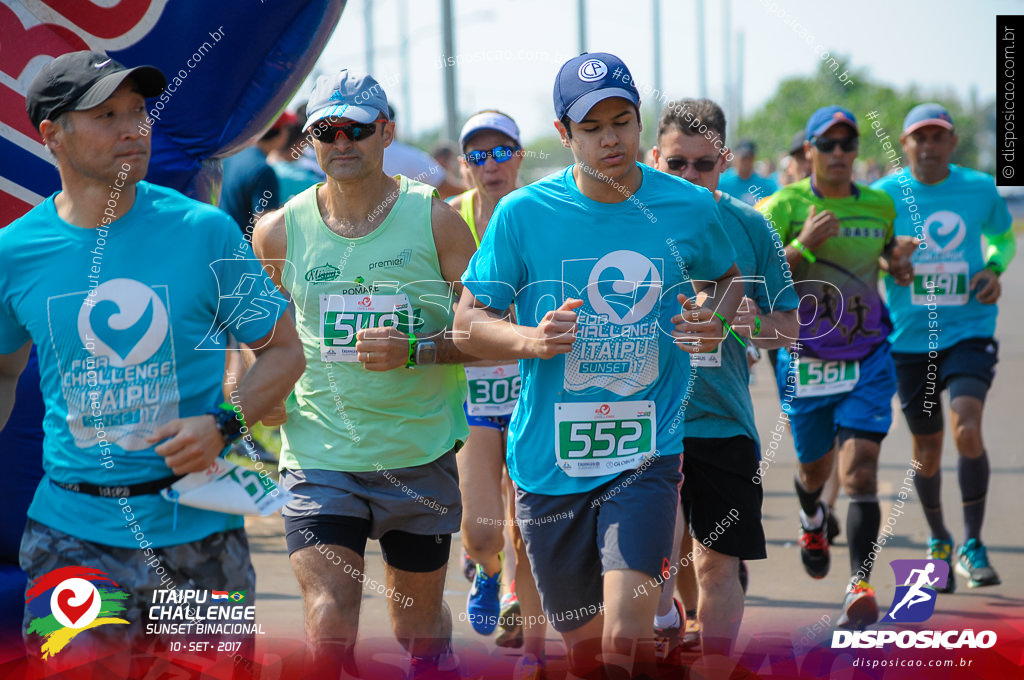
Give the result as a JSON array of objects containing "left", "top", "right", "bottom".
[{"left": 281, "top": 177, "right": 469, "bottom": 472}]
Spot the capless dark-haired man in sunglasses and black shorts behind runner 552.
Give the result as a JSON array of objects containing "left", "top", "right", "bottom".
[{"left": 653, "top": 99, "right": 799, "bottom": 656}]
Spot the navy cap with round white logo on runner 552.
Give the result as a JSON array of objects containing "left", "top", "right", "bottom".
[{"left": 554, "top": 52, "right": 640, "bottom": 123}]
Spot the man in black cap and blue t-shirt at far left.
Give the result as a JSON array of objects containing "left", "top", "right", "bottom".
[{"left": 0, "top": 51, "right": 304, "bottom": 663}]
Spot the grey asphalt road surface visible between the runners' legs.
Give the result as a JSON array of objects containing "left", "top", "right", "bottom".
[{"left": 247, "top": 236, "right": 1024, "bottom": 677}]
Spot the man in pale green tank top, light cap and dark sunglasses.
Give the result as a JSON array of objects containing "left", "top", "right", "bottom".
[{"left": 253, "top": 70, "right": 473, "bottom": 677}]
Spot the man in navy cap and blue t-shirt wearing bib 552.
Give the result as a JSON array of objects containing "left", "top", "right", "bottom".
[{"left": 455, "top": 52, "right": 742, "bottom": 677}]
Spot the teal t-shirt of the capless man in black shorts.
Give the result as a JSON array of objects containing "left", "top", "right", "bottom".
[{"left": 686, "top": 194, "right": 800, "bottom": 450}]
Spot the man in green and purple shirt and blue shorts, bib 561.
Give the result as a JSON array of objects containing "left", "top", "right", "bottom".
[{"left": 760, "top": 105, "right": 915, "bottom": 629}]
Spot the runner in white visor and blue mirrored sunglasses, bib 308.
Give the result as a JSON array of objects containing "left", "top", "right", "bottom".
[{"left": 451, "top": 110, "right": 547, "bottom": 678}]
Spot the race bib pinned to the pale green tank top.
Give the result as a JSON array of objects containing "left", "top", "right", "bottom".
[{"left": 319, "top": 293, "right": 413, "bottom": 362}]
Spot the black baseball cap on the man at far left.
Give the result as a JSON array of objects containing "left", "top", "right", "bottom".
[{"left": 25, "top": 50, "right": 167, "bottom": 130}]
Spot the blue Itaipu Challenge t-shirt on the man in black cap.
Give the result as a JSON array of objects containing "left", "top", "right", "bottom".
[{"left": 0, "top": 182, "right": 286, "bottom": 548}]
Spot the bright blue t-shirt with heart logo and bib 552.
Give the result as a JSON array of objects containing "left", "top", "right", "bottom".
[{"left": 463, "top": 165, "right": 735, "bottom": 496}]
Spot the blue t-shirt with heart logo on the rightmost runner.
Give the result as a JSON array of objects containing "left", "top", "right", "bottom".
[{"left": 873, "top": 165, "right": 1013, "bottom": 353}]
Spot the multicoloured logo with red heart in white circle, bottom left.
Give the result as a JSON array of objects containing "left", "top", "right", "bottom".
[{"left": 25, "top": 566, "right": 128, "bottom": 658}]
